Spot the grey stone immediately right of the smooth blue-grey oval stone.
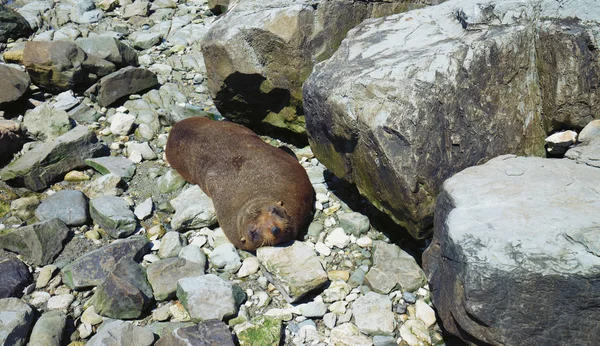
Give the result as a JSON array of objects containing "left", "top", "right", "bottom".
[{"left": 90, "top": 196, "right": 137, "bottom": 238}]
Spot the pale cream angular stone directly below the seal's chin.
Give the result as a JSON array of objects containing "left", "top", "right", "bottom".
[{"left": 256, "top": 241, "right": 327, "bottom": 303}]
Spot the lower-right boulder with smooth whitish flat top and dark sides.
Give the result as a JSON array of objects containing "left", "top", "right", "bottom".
[{"left": 423, "top": 155, "right": 600, "bottom": 346}]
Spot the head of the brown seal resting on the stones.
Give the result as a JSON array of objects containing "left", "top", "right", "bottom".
[{"left": 240, "top": 202, "right": 295, "bottom": 250}]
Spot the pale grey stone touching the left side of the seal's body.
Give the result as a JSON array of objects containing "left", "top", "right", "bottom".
[{"left": 171, "top": 185, "right": 217, "bottom": 230}]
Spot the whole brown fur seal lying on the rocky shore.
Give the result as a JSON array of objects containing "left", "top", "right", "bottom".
[{"left": 166, "top": 117, "right": 314, "bottom": 250}]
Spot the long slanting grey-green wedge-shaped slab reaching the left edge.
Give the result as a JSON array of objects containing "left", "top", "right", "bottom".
[{"left": 0, "top": 125, "right": 104, "bottom": 191}]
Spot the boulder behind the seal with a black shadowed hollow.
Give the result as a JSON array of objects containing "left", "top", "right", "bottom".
[{"left": 202, "top": 0, "right": 424, "bottom": 134}]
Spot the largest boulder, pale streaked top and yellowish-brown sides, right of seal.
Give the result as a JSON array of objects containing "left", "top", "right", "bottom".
[{"left": 304, "top": 0, "right": 600, "bottom": 238}]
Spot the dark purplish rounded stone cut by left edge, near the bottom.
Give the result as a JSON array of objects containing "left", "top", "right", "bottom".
[{"left": 0, "top": 256, "right": 33, "bottom": 298}]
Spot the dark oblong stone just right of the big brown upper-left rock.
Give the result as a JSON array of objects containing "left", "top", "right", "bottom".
[{"left": 86, "top": 66, "right": 158, "bottom": 107}]
